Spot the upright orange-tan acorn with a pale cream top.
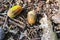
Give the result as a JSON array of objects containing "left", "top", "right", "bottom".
[{"left": 27, "top": 10, "right": 36, "bottom": 25}]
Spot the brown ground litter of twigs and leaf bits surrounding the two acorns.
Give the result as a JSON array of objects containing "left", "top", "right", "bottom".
[{"left": 0, "top": 0, "right": 60, "bottom": 40}]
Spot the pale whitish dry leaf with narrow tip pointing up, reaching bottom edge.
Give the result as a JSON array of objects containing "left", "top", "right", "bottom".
[{"left": 40, "top": 14, "right": 58, "bottom": 40}]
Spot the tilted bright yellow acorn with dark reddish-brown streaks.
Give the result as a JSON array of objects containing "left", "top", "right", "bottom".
[{"left": 7, "top": 5, "right": 22, "bottom": 18}]
